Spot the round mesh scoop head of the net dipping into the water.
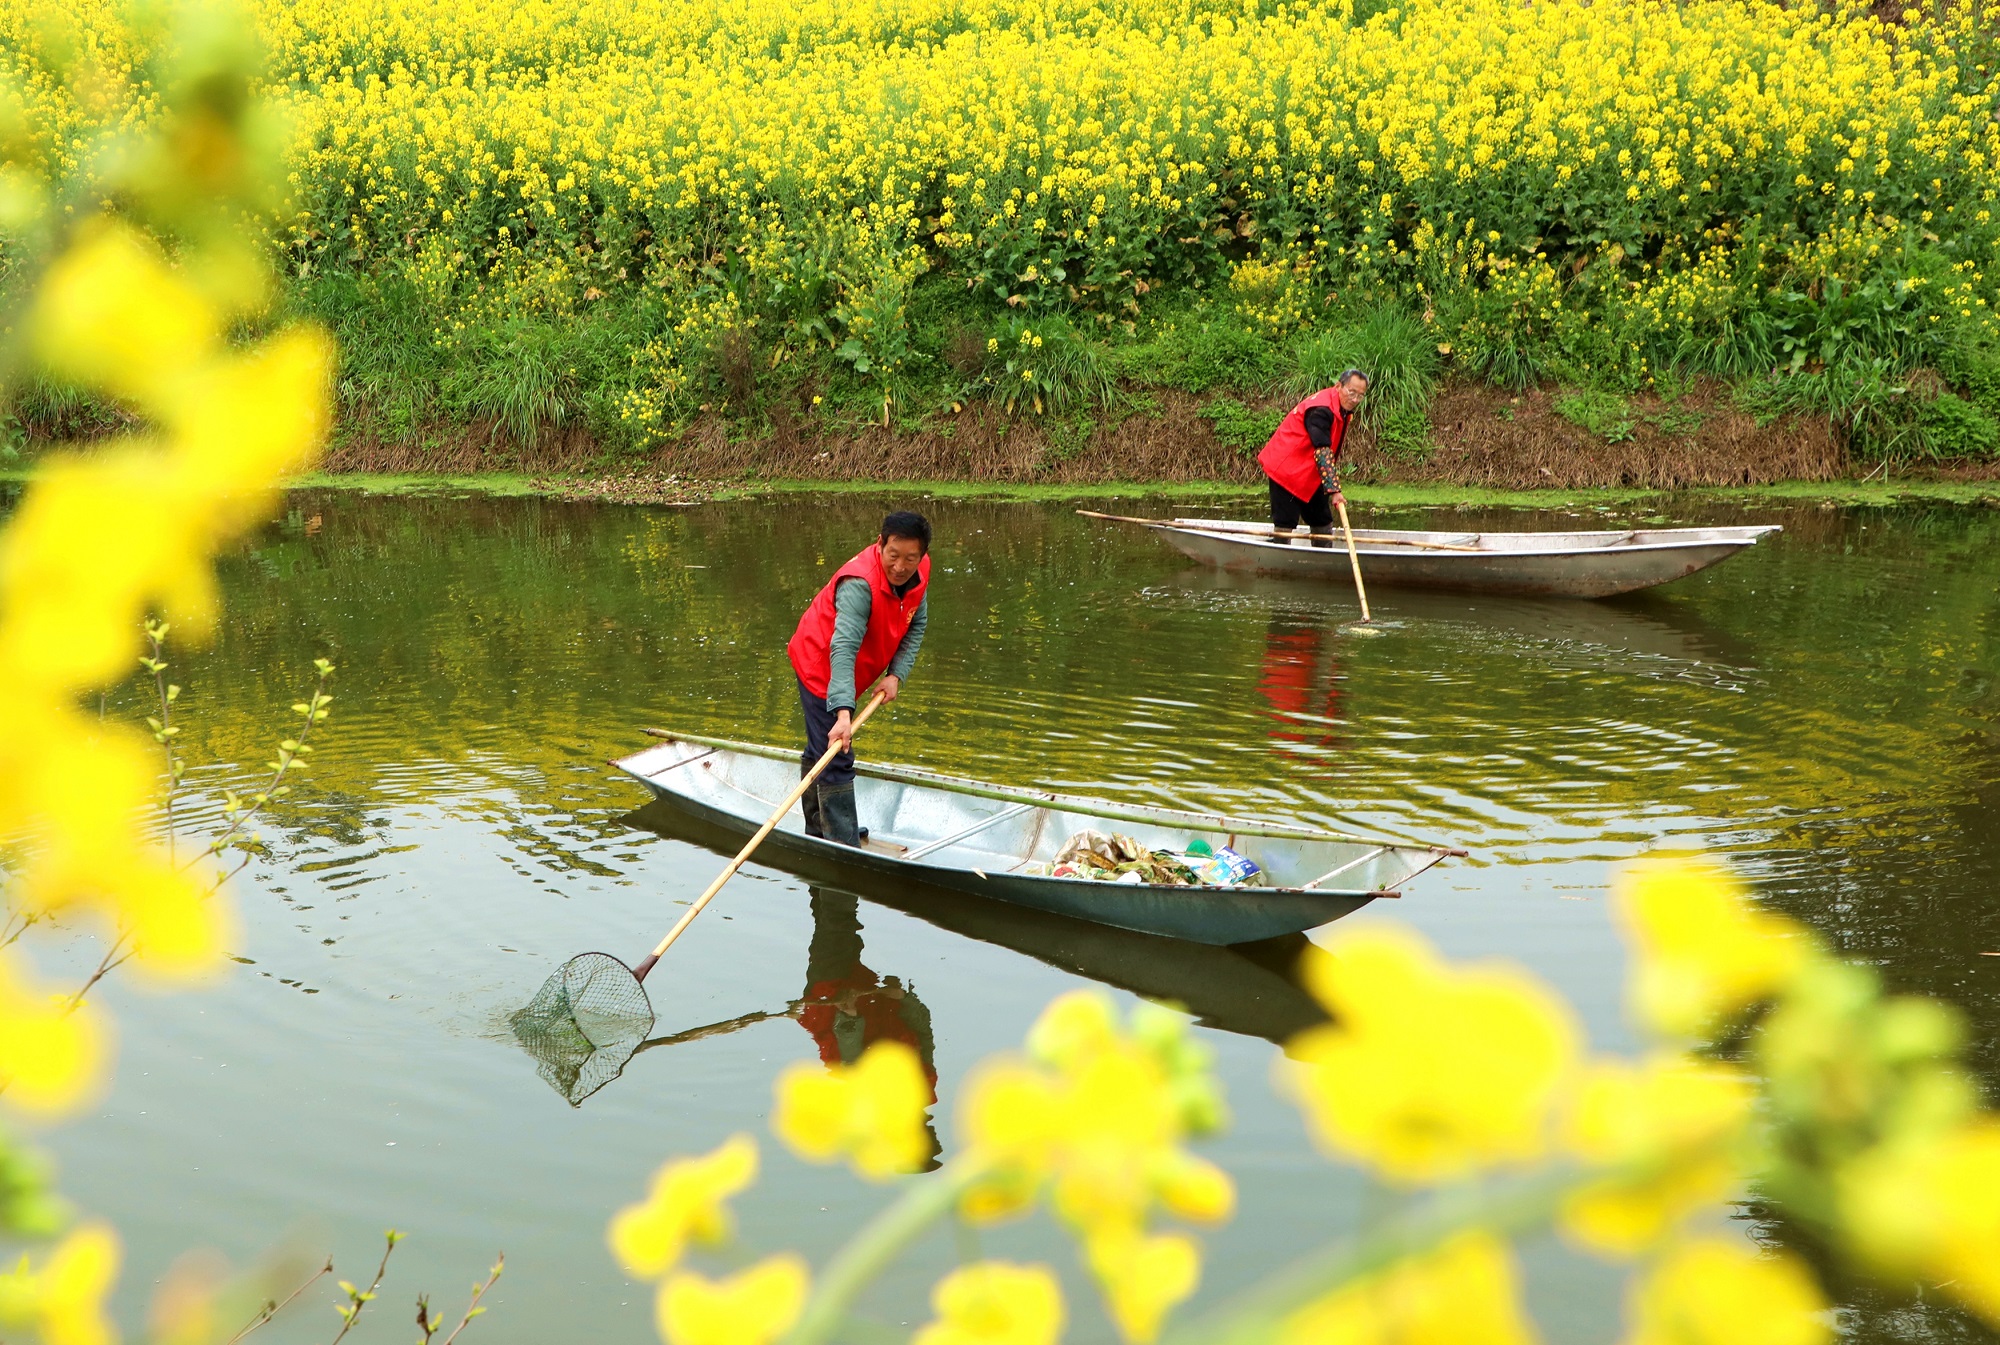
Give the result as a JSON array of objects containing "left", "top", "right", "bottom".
[{"left": 510, "top": 953, "right": 652, "bottom": 1107}]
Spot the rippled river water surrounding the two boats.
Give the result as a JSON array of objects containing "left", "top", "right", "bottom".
[{"left": 27, "top": 492, "right": 2000, "bottom": 1343}]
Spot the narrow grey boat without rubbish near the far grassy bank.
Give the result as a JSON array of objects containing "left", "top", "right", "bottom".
[{"left": 1078, "top": 510, "right": 1782, "bottom": 598}]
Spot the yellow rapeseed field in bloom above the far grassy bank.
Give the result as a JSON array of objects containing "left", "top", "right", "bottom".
[{"left": 0, "top": 0, "right": 2000, "bottom": 440}]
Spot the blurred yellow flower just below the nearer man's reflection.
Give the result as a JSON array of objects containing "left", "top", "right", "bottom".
[{"left": 772, "top": 1041, "right": 930, "bottom": 1181}]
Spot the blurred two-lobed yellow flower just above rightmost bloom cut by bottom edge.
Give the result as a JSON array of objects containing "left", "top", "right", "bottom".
[{"left": 1562, "top": 1055, "right": 1756, "bottom": 1255}]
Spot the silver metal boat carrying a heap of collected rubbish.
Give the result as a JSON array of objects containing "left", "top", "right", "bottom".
[{"left": 612, "top": 729, "right": 1464, "bottom": 945}]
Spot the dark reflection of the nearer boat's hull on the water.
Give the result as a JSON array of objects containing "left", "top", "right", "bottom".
[{"left": 624, "top": 801, "right": 1326, "bottom": 1045}]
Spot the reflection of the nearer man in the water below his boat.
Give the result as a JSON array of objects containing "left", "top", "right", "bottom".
[{"left": 798, "top": 887, "right": 942, "bottom": 1169}]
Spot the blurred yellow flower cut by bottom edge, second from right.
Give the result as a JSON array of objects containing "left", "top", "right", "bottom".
[{"left": 1278, "top": 1229, "right": 1536, "bottom": 1345}]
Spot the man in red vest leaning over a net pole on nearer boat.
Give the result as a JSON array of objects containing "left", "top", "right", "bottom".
[{"left": 784, "top": 512, "right": 930, "bottom": 845}]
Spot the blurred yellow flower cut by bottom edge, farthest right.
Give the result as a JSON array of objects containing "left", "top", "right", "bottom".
[{"left": 1624, "top": 1237, "right": 1834, "bottom": 1345}]
